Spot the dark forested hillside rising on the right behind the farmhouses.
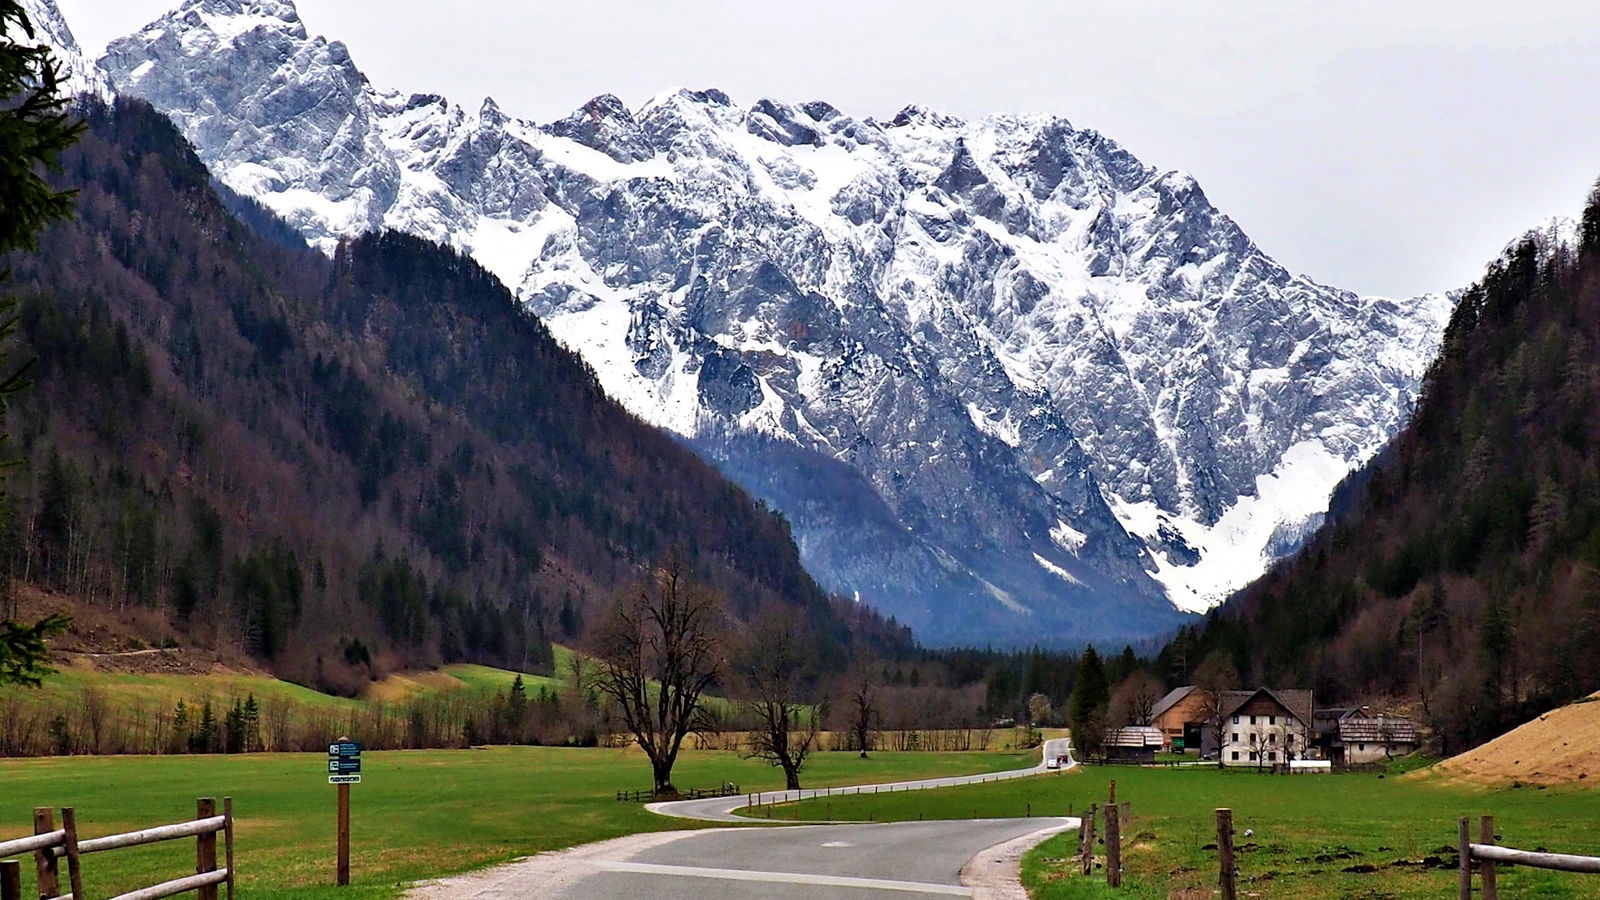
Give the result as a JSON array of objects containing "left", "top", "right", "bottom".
[{"left": 1165, "top": 189, "right": 1600, "bottom": 753}]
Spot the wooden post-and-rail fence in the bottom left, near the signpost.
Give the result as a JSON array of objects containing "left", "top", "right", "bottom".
[{"left": 0, "top": 798, "right": 234, "bottom": 900}]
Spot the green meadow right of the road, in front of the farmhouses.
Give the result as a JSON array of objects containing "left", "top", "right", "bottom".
[{"left": 774, "top": 767, "right": 1600, "bottom": 900}]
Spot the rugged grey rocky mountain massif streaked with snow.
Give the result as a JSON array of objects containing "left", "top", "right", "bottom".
[{"left": 30, "top": 0, "right": 1453, "bottom": 644}]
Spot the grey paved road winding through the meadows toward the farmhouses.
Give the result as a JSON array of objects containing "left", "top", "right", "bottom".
[{"left": 408, "top": 740, "right": 1077, "bottom": 900}]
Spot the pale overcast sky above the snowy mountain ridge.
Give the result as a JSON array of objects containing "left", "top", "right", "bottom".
[{"left": 58, "top": 0, "right": 1600, "bottom": 296}]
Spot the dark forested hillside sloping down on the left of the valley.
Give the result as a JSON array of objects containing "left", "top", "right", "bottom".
[{"left": 0, "top": 101, "right": 909, "bottom": 690}]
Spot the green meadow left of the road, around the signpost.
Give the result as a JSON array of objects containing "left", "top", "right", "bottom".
[{"left": 0, "top": 748, "right": 1034, "bottom": 898}]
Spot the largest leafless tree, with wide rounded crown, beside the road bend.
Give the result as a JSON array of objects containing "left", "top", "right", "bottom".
[{"left": 595, "top": 559, "right": 725, "bottom": 796}]
